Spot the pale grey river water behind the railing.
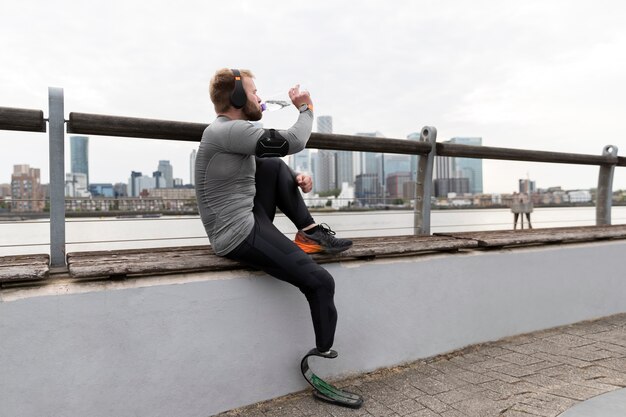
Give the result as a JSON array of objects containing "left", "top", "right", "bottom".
[{"left": 0, "top": 206, "right": 626, "bottom": 256}]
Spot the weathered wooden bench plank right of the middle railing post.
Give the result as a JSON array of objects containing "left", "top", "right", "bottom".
[{"left": 437, "top": 225, "right": 626, "bottom": 247}]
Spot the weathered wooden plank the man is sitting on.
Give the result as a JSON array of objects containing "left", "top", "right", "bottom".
[{"left": 67, "top": 236, "right": 477, "bottom": 278}]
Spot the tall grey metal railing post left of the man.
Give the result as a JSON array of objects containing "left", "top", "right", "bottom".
[{"left": 48, "top": 87, "right": 66, "bottom": 267}]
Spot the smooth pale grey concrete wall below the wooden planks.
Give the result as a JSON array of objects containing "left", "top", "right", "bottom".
[{"left": 0, "top": 241, "right": 626, "bottom": 417}]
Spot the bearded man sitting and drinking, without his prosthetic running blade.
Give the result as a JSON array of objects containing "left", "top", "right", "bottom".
[{"left": 195, "top": 68, "right": 352, "bottom": 357}]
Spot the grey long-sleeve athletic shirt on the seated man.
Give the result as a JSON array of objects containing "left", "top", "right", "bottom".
[{"left": 195, "top": 110, "right": 313, "bottom": 256}]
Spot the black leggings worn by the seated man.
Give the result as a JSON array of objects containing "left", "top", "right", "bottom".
[{"left": 226, "top": 158, "right": 337, "bottom": 352}]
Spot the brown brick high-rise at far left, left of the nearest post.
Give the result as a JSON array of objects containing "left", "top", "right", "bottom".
[{"left": 11, "top": 165, "right": 45, "bottom": 211}]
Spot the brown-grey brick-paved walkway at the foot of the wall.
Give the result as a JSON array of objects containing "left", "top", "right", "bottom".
[{"left": 220, "top": 314, "right": 626, "bottom": 417}]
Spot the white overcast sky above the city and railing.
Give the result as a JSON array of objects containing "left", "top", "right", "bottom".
[{"left": 0, "top": 0, "right": 626, "bottom": 192}]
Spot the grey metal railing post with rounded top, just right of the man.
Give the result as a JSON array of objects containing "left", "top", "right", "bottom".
[{"left": 413, "top": 126, "right": 437, "bottom": 235}]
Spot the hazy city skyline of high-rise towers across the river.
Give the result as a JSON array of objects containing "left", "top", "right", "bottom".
[{"left": 0, "top": 128, "right": 619, "bottom": 196}]
